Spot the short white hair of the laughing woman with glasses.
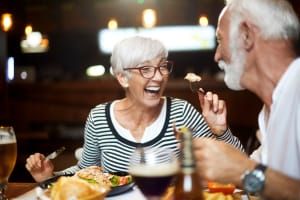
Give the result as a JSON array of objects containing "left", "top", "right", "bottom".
[{"left": 110, "top": 36, "right": 168, "bottom": 77}]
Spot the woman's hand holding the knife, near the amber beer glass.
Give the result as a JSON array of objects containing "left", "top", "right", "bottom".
[{"left": 25, "top": 153, "right": 54, "bottom": 182}]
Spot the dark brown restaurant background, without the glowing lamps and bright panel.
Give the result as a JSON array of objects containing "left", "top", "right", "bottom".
[{"left": 0, "top": 0, "right": 300, "bottom": 181}]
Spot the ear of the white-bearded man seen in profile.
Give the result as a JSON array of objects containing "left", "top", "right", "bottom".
[{"left": 240, "top": 21, "right": 255, "bottom": 51}]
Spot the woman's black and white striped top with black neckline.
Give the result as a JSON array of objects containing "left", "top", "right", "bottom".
[{"left": 58, "top": 97, "right": 243, "bottom": 174}]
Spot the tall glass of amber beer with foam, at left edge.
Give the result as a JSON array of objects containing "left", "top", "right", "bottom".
[{"left": 0, "top": 126, "right": 17, "bottom": 200}]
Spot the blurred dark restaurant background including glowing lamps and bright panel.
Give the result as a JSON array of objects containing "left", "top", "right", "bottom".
[{"left": 0, "top": 0, "right": 300, "bottom": 181}]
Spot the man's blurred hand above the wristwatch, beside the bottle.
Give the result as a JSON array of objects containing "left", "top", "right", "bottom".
[{"left": 193, "top": 138, "right": 256, "bottom": 187}]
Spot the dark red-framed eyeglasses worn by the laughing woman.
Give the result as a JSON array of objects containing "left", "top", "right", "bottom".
[{"left": 124, "top": 61, "right": 174, "bottom": 79}]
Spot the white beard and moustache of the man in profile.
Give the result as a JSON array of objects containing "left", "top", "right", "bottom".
[{"left": 218, "top": 47, "right": 245, "bottom": 90}]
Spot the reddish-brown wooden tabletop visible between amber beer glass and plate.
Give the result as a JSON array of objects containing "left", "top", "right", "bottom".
[{"left": 6, "top": 183, "right": 37, "bottom": 199}]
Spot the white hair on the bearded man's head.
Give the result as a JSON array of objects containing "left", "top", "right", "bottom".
[{"left": 226, "top": 0, "right": 300, "bottom": 41}]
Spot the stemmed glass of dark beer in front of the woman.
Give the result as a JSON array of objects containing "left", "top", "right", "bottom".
[{"left": 128, "top": 147, "right": 179, "bottom": 200}]
